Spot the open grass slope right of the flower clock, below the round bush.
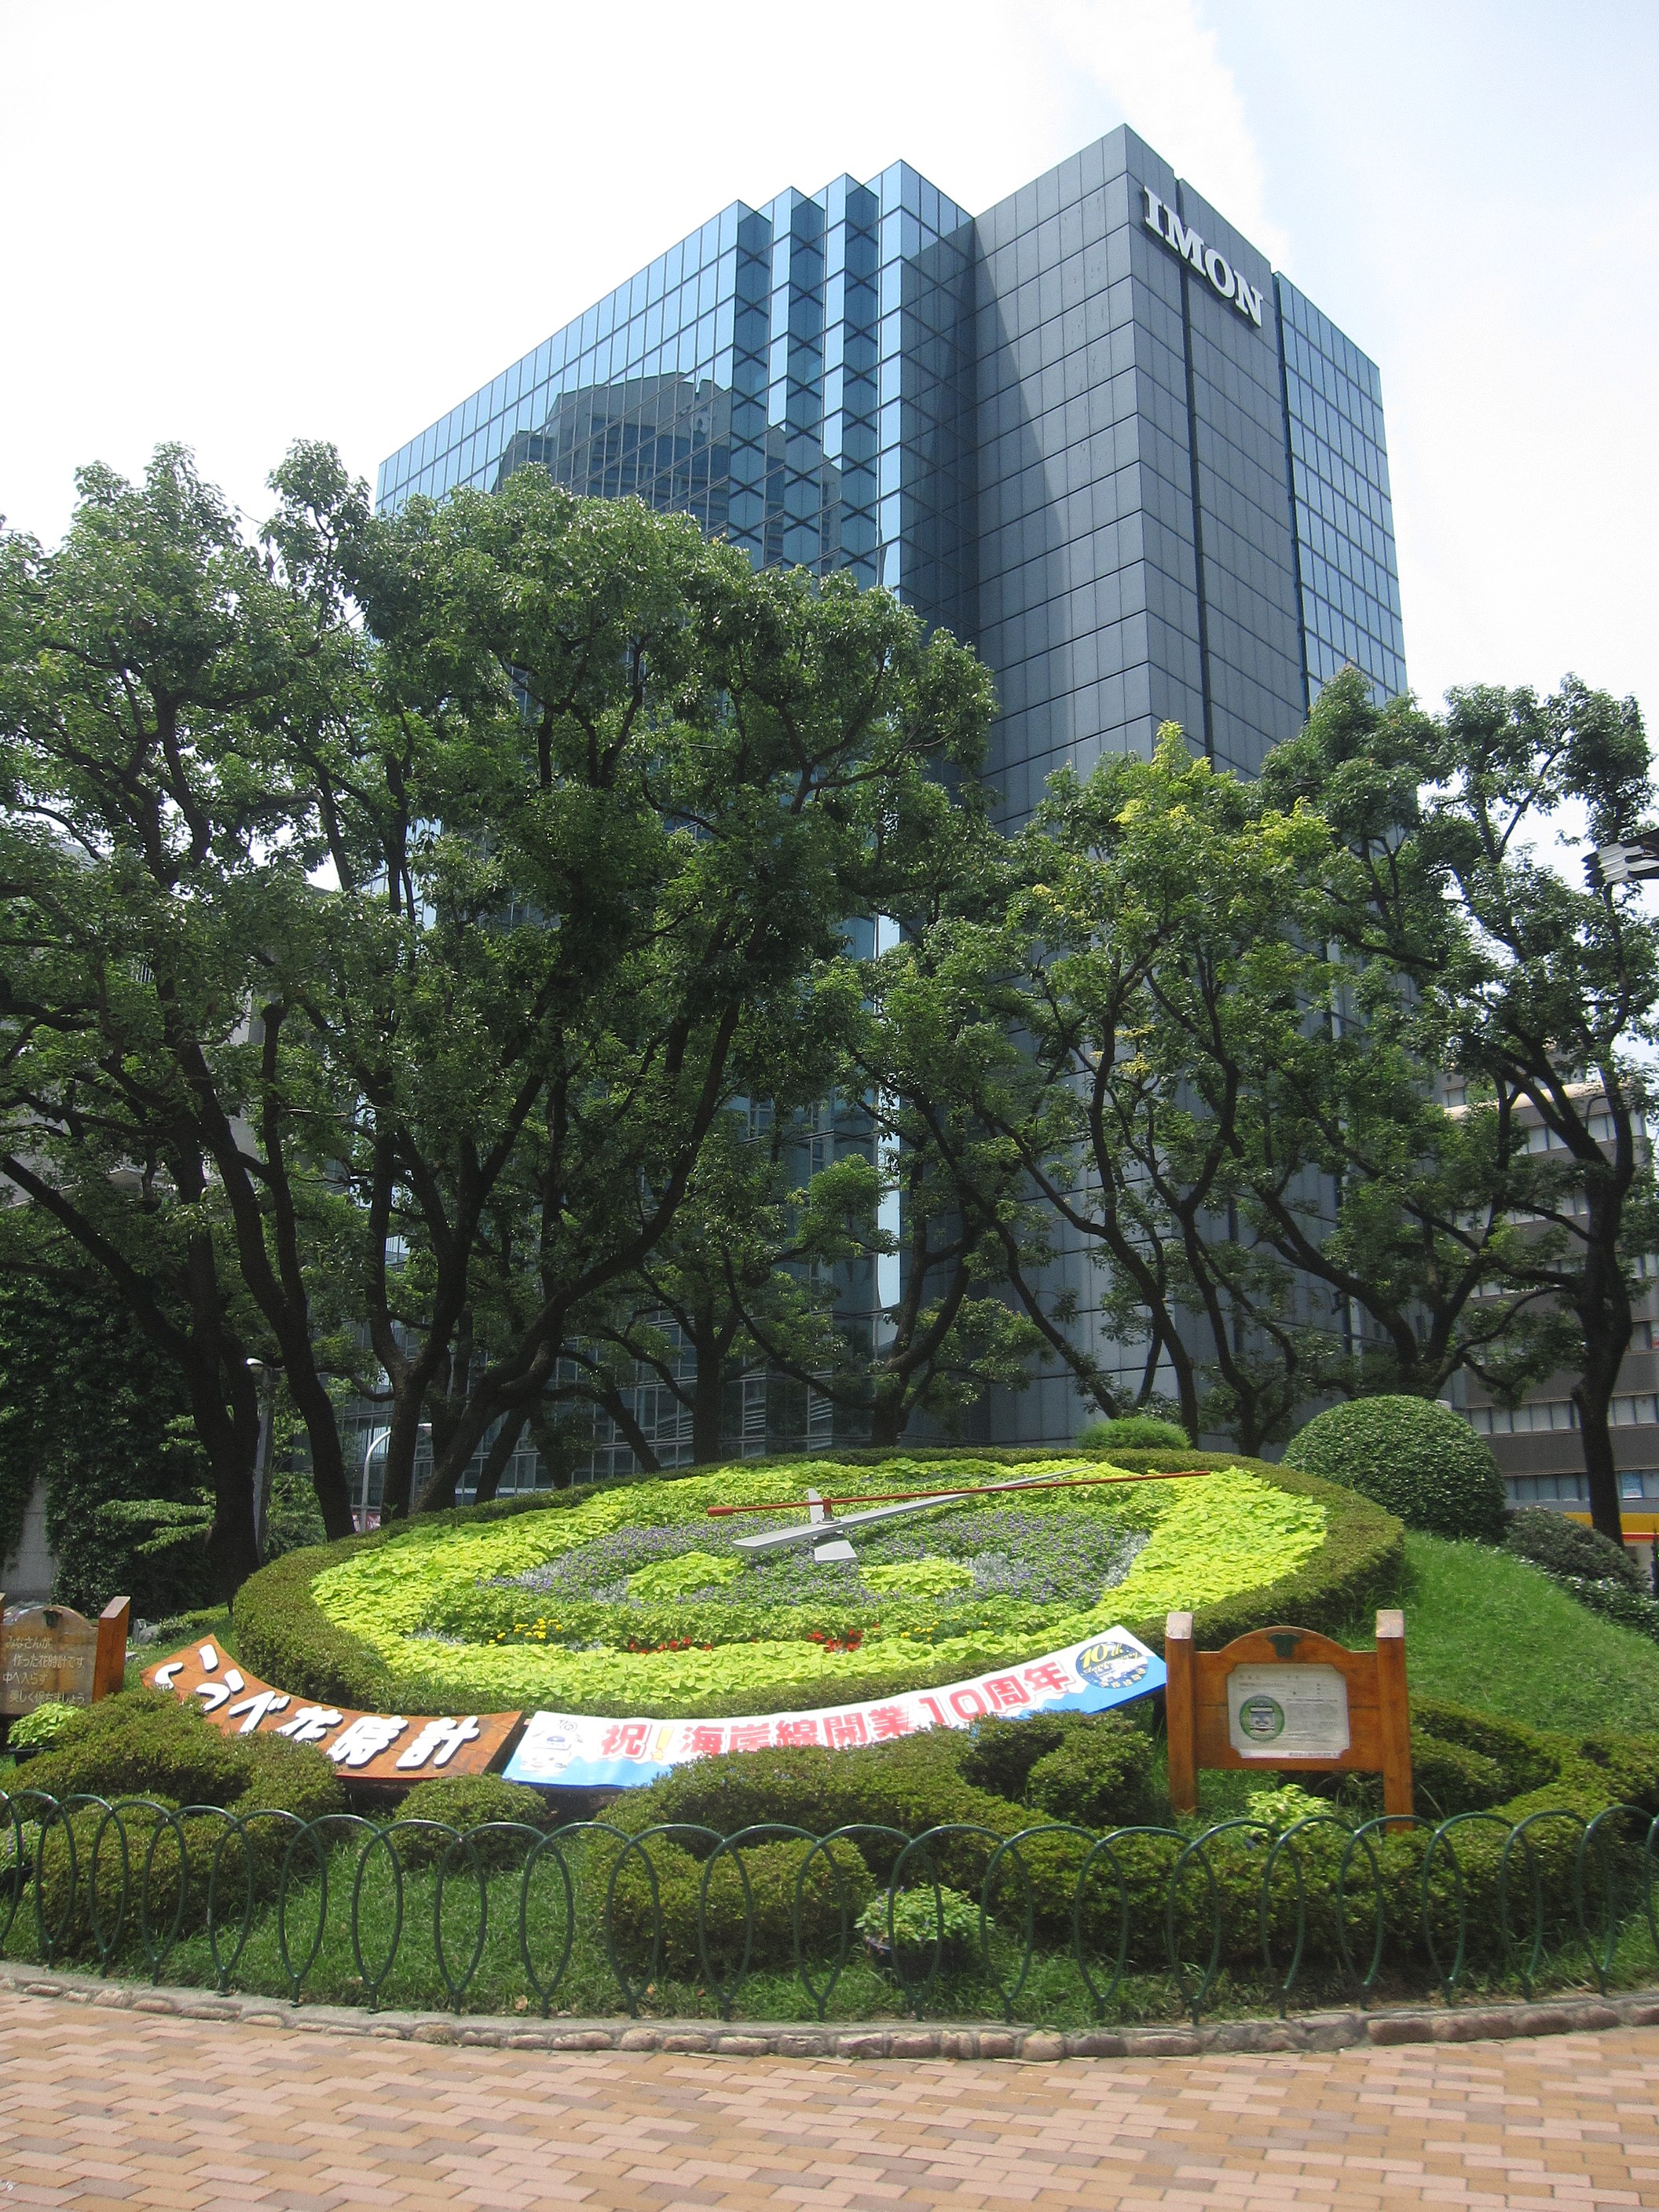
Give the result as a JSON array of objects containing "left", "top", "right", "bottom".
[{"left": 1404, "top": 1535, "right": 1659, "bottom": 1737}]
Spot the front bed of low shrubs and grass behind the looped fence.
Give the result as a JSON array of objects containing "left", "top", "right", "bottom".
[{"left": 13, "top": 1699, "right": 1659, "bottom": 2024}]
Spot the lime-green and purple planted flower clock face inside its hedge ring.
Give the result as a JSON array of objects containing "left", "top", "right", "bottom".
[{"left": 312, "top": 1456, "right": 1325, "bottom": 1716}]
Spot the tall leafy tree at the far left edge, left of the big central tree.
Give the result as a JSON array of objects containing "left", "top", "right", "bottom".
[{"left": 0, "top": 449, "right": 363, "bottom": 1591}]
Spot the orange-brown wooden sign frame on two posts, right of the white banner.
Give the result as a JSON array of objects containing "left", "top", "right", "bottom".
[{"left": 1163, "top": 1610, "right": 1412, "bottom": 1818}]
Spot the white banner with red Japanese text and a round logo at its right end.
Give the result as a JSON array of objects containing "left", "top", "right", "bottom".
[{"left": 507, "top": 1628, "right": 1167, "bottom": 1789}]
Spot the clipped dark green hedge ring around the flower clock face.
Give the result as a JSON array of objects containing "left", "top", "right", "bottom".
[{"left": 233, "top": 1445, "right": 1404, "bottom": 1719}]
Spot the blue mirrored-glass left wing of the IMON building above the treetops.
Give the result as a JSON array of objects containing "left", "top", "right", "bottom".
[{"left": 380, "top": 163, "right": 973, "bottom": 635}]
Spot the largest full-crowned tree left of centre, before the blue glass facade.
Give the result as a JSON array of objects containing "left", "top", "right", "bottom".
[{"left": 323, "top": 471, "right": 991, "bottom": 1515}]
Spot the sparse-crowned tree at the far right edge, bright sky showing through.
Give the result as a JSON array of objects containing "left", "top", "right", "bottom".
[{"left": 1268, "top": 677, "right": 1659, "bottom": 1535}]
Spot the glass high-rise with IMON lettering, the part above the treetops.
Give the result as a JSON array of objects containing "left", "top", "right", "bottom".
[{"left": 379, "top": 130, "right": 1404, "bottom": 1468}]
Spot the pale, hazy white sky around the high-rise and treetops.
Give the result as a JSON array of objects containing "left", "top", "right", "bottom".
[{"left": 0, "top": 0, "right": 1659, "bottom": 730}]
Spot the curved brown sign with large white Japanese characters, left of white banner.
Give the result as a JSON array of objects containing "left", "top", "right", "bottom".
[{"left": 144, "top": 1641, "right": 518, "bottom": 1785}]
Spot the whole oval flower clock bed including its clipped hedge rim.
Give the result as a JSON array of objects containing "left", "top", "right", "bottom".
[{"left": 234, "top": 1451, "right": 1401, "bottom": 1716}]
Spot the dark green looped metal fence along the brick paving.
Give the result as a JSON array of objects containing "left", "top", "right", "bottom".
[{"left": 0, "top": 1789, "right": 1659, "bottom": 2022}]
